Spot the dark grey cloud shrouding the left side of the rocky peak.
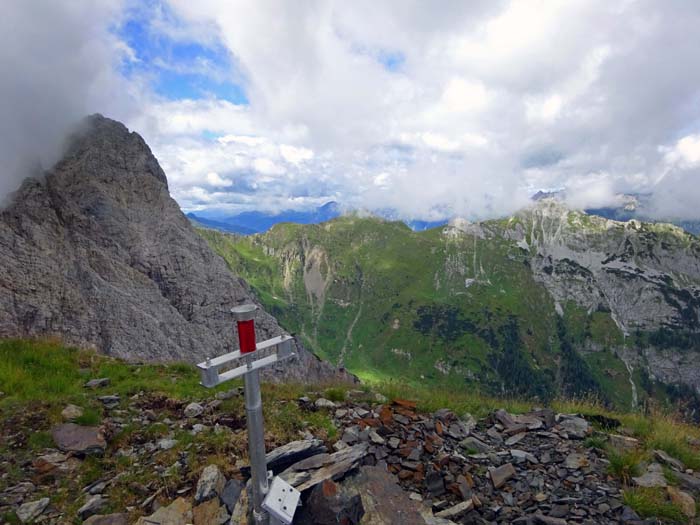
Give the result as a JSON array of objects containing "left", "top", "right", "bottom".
[{"left": 0, "top": 0, "right": 136, "bottom": 201}]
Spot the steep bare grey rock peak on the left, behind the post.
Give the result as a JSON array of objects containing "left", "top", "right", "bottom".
[{"left": 0, "top": 115, "right": 350, "bottom": 381}]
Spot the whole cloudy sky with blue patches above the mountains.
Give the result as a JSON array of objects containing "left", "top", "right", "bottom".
[{"left": 0, "top": 0, "right": 700, "bottom": 220}]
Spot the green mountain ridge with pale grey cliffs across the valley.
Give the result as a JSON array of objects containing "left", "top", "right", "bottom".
[{"left": 200, "top": 202, "right": 700, "bottom": 418}]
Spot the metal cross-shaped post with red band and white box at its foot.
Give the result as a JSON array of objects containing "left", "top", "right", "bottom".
[{"left": 197, "top": 304, "right": 299, "bottom": 525}]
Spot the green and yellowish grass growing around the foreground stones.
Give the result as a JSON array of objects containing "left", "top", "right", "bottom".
[{"left": 0, "top": 340, "right": 700, "bottom": 523}]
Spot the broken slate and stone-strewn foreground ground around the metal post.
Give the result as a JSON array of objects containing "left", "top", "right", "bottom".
[{"left": 0, "top": 378, "right": 700, "bottom": 525}]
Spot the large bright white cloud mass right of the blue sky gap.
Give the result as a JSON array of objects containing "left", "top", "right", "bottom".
[{"left": 146, "top": 0, "right": 700, "bottom": 217}]
